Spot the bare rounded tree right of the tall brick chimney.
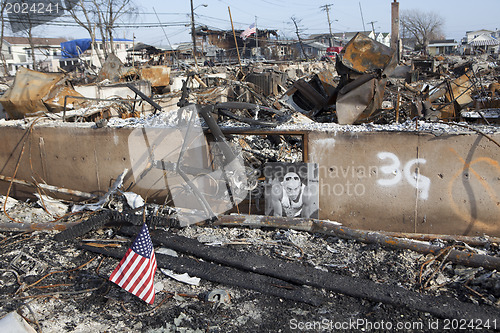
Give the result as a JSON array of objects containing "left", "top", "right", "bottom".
[{"left": 400, "top": 9, "right": 444, "bottom": 54}]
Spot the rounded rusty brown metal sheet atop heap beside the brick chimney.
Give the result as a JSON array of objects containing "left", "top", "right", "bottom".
[{"left": 340, "top": 33, "right": 395, "bottom": 73}]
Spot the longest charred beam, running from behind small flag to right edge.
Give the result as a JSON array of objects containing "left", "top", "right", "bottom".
[{"left": 122, "top": 227, "right": 500, "bottom": 320}]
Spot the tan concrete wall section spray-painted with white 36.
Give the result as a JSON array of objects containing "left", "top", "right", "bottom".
[{"left": 308, "top": 132, "right": 500, "bottom": 236}]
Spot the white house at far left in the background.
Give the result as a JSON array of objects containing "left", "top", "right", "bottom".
[{"left": 0, "top": 37, "right": 66, "bottom": 75}]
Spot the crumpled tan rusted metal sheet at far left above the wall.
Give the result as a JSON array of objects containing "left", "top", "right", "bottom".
[{"left": 0, "top": 67, "right": 81, "bottom": 119}]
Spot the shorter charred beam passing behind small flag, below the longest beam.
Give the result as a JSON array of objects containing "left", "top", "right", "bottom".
[{"left": 80, "top": 245, "right": 324, "bottom": 306}]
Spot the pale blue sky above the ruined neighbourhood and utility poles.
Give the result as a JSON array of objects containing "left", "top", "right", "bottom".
[{"left": 17, "top": 0, "right": 500, "bottom": 45}]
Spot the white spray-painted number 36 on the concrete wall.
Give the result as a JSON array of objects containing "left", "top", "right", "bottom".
[{"left": 377, "top": 152, "right": 431, "bottom": 200}]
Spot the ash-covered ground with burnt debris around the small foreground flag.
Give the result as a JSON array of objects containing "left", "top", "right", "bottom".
[{"left": 0, "top": 197, "right": 500, "bottom": 332}]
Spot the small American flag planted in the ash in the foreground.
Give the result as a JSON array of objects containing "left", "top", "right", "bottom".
[{"left": 109, "top": 223, "right": 156, "bottom": 304}]
